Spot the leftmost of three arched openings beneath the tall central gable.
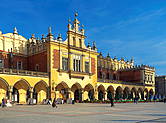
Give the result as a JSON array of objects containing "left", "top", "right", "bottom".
[{"left": 55, "top": 82, "right": 69, "bottom": 103}]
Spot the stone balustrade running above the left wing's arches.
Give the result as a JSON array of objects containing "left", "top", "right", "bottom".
[{"left": 0, "top": 68, "right": 48, "bottom": 78}]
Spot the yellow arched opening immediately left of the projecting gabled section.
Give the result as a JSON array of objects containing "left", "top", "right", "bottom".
[{"left": 33, "top": 81, "right": 48, "bottom": 103}]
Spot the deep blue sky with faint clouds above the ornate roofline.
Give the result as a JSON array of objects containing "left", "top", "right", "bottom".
[{"left": 0, "top": 0, "right": 166, "bottom": 75}]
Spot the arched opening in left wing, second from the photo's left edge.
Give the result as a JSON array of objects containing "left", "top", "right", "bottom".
[{"left": 12, "top": 79, "right": 30, "bottom": 103}]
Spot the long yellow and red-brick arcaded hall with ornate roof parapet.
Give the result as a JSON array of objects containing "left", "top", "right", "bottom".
[{"left": 0, "top": 16, "right": 155, "bottom": 104}]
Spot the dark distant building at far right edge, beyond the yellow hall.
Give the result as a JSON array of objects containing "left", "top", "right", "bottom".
[{"left": 155, "top": 76, "right": 166, "bottom": 99}]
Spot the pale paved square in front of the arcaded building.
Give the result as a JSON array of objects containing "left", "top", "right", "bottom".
[{"left": 0, "top": 103, "right": 166, "bottom": 123}]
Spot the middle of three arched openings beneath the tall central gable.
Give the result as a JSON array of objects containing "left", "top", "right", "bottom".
[{"left": 71, "top": 83, "right": 83, "bottom": 102}]
